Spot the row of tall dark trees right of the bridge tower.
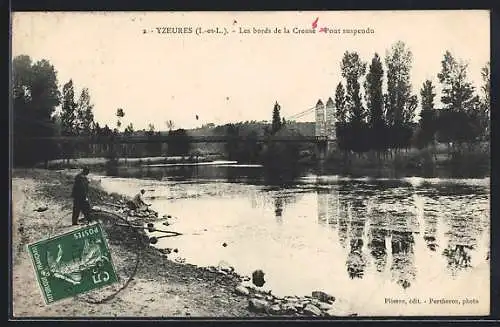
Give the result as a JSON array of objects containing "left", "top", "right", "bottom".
[{"left": 334, "top": 41, "right": 490, "bottom": 153}]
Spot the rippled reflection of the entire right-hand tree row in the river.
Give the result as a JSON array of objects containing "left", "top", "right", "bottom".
[{"left": 317, "top": 182, "right": 488, "bottom": 289}]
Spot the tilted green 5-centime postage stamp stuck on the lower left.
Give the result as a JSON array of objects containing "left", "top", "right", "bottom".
[{"left": 28, "top": 223, "right": 118, "bottom": 304}]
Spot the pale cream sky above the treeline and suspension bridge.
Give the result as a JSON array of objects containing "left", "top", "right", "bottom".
[{"left": 12, "top": 10, "right": 490, "bottom": 129}]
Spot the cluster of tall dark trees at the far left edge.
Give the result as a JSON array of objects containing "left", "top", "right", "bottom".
[{"left": 12, "top": 55, "right": 113, "bottom": 165}]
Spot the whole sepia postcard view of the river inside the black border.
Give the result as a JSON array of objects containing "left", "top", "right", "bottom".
[{"left": 9, "top": 10, "right": 491, "bottom": 320}]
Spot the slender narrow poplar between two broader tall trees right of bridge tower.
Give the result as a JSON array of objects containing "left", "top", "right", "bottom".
[{"left": 365, "top": 53, "right": 386, "bottom": 151}]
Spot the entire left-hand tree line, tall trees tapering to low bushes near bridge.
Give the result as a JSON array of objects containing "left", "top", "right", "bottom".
[{"left": 12, "top": 55, "right": 195, "bottom": 166}]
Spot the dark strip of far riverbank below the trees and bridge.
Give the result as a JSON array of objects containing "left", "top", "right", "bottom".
[{"left": 39, "top": 143, "right": 491, "bottom": 180}]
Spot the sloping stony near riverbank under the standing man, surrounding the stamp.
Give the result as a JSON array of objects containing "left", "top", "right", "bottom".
[{"left": 12, "top": 169, "right": 351, "bottom": 317}]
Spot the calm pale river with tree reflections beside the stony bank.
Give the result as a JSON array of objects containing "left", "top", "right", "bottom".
[{"left": 93, "top": 164, "right": 490, "bottom": 315}]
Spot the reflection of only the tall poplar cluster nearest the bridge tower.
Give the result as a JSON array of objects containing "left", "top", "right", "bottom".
[{"left": 318, "top": 185, "right": 422, "bottom": 289}]
